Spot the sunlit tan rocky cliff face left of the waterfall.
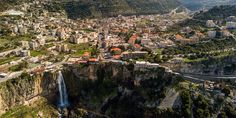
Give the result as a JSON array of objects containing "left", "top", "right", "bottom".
[{"left": 0, "top": 73, "right": 57, "bottom": 114}]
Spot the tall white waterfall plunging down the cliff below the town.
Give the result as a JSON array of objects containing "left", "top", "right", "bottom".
[{"left": 57, "top": 71, "right": 69, "bottom": 108}]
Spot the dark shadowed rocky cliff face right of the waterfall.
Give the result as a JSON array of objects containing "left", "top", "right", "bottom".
[{"left": 63, "top": 63, "right": 182, "bottom": 118}]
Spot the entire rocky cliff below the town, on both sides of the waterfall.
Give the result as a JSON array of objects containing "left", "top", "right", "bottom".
[{"left": 0, "top": 63, "right": 183, "bottom": 118}]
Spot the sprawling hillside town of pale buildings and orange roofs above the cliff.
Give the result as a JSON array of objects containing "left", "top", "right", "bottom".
[{"left": 0, "top": 1, "right": 236, "bottom": 117}]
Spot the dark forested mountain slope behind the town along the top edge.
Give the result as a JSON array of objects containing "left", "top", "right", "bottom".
[{"left": 0, "top": 0, "right": 180, "bottom": 19}]
